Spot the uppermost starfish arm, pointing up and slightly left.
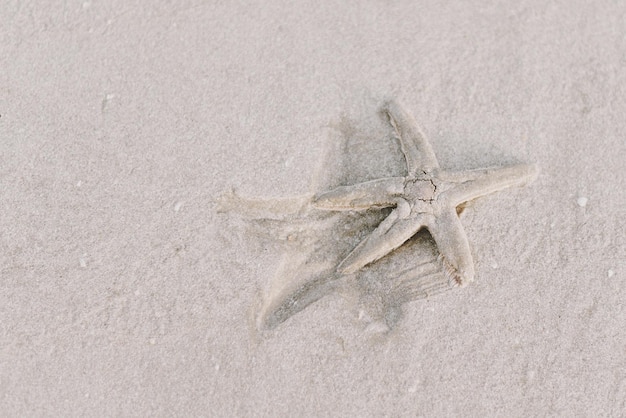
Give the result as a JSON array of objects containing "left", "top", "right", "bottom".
[{"left": 383, "top": 100, "right": 439, "bottom": 174}]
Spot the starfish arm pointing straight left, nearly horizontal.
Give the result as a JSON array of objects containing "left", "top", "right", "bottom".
[{"left": 313, "top": 177, "right": 404, "bottom": 210}]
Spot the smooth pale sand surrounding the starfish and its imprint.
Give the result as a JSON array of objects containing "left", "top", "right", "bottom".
[{"left": 0, "top": 0, "right": 626, "bottom": 416}]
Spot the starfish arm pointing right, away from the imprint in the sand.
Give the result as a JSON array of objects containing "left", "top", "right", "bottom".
[{"left": 442, "top": 164, "right": 539, "bottom": 206}]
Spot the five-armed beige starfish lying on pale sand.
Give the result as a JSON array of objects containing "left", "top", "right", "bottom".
[{"left": 314, "top": 101, "right": 539, "bottom": 286}]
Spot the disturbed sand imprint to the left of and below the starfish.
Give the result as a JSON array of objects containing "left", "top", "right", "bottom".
[{"left": 219, "top": 193, "right": 453, "bottom": 330}]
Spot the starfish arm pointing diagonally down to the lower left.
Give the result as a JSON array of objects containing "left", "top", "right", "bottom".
[{"left": 337, "top": 207, "right": 424, "bottom": 274}]
